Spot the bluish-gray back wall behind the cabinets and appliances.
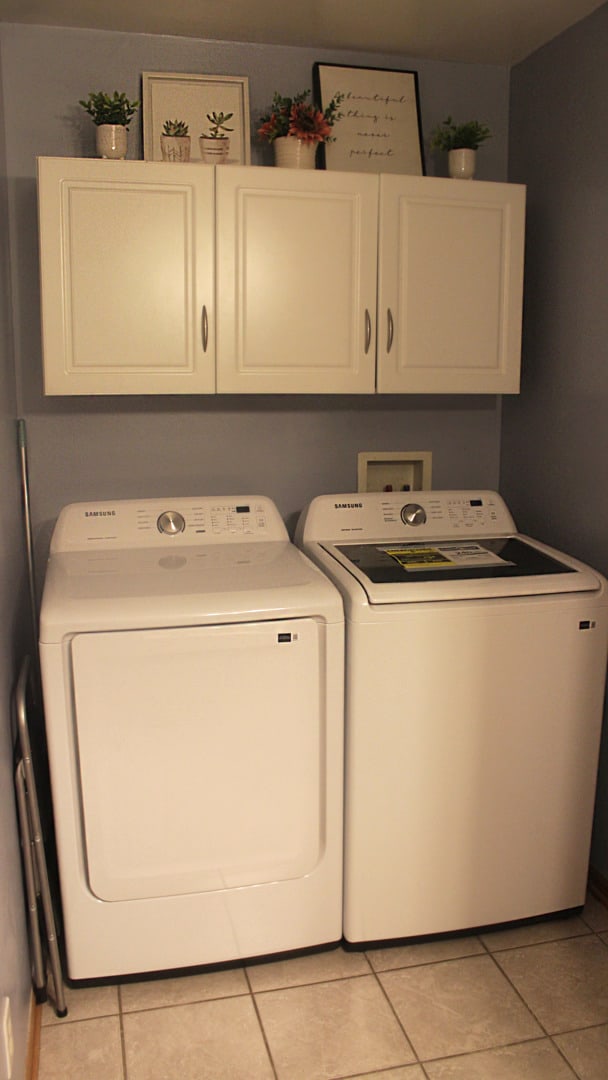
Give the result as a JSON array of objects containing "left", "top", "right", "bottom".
[{"left": 0, "top": 25, "right": 509, "bottom": 578}]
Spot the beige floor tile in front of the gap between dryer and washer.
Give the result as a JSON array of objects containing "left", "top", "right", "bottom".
[{"left": 254, "top": 975, "right": 415, "bottom": 1080}]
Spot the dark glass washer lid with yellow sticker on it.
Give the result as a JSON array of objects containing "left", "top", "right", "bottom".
[{"left": 320, "top": 535, "right": 603, "bottom": 604}]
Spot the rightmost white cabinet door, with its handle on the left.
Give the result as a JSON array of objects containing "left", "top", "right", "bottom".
[{"left": 378, "top": 176, "right": 525, "bottom": 394}]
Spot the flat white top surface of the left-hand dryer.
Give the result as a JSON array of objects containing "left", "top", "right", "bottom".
[{"left": 40, "top": 540, "right": 343, "bottom": 643}]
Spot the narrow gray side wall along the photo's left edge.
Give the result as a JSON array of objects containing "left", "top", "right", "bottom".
[{"left": 0, "top": 38, "right": 31, "bottom": 1080}]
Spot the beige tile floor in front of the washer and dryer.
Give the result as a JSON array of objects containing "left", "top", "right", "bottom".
[{"left": 39, "top": 897, "right": 608, "bottom": 1080}]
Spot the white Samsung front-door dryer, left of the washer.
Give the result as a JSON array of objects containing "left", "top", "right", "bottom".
[{"left": 40, "top": 496, "right": 343, "bottom": 980}]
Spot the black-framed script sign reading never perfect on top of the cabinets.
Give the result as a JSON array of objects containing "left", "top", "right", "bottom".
[{"left": 312, "top": 63, "right": 424, "bottom": 176}]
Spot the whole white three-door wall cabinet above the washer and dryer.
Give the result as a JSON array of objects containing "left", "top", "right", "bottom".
[{"left": 39, "top": 159, "right": 525, "bottom": 394}]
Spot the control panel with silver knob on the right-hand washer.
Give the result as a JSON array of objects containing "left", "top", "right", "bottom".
[{"left": 296, "top": 491, "right": 516, "bottom": 543}]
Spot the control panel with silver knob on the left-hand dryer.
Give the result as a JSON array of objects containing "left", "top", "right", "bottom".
[{"left": 51, "top": 496, "right": 289, "bottom": 554}]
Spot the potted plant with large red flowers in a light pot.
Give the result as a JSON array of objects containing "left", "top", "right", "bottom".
[{"left": 257, "top": 90, "right": 344, "bottom": 168}]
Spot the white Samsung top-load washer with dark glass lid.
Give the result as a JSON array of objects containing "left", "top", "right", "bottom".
[{"left": 296, "top": 490, "right": 608, "bottom": 943}]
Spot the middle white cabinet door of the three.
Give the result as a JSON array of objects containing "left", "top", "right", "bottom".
[{"left": 216, "top": 166, "right": 378, "bottom": 393}]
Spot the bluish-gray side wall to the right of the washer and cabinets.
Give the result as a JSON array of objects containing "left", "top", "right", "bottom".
[{"left": 501, "top": 4, "right": 608, "bottom": 878}]
